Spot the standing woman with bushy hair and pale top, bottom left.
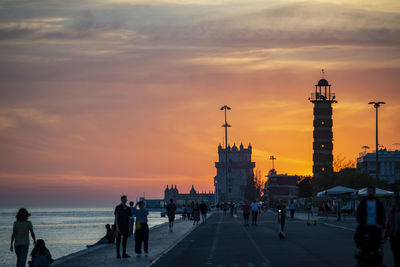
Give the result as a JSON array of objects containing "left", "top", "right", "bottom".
[{"left": 10, "top": 208, "right": 36, "bottom": 267}]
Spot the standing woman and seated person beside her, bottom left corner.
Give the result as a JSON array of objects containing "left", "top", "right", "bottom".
[{"left": 10, "top": 208, "right": 53, "bottom": 267}]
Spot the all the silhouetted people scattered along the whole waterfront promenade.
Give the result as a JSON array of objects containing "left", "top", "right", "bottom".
[{"left": 10, "top": 187, "right": 400, "bottom": 267}]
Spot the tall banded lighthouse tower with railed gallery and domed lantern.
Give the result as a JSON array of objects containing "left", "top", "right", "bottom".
[{"left": 308, "top": 75, "right": 337, "bottom": 177}]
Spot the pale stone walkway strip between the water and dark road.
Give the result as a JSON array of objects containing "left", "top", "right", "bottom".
[{"left": 52, "top": 220, "right": 197, "bottom": 267}]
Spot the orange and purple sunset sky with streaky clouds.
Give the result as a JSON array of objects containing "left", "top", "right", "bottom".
[{"left": 0, "top": 0, "right": 400, "bottom": 205}]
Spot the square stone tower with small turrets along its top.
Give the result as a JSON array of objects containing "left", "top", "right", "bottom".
[{"left": 214, "top": 144, "right": 255, "bottom": 203}]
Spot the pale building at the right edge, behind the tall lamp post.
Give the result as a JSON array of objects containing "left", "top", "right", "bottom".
[{"left": 357, "top": 149, "right": 400, "bottom": 184}]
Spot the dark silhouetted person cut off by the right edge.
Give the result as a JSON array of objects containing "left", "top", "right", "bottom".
[{"left": 385, "top": 196, "right": 400, "bottom": 267}]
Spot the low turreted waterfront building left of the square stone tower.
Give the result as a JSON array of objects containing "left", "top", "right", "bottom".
[{"left": 164, "top": 185, "right": 215, "bottom": 206}]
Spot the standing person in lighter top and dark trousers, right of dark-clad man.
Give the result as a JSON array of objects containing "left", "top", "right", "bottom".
[{"left": 134, "top": 201, "right": 149, "bottom": 257}]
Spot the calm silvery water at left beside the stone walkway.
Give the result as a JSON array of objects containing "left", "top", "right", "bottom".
[{"left": 0, "top": 207, "right": 167, "bottom": 266}]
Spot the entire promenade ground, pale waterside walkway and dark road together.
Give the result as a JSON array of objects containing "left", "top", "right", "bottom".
[{"left": 50, "top": 211, "right": 394, "bottom": 267}]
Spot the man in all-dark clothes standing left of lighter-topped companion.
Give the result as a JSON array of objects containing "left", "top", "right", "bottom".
[{"left": 114, "top": 196, "right": 132, "bottom": 258}]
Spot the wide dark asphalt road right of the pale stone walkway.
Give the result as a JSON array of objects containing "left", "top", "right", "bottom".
[{"left": 154, "top": 212, "right": 394, "bottom": 267}]
